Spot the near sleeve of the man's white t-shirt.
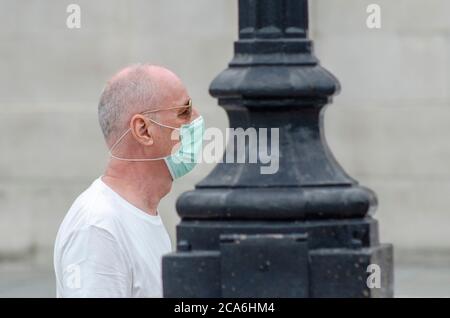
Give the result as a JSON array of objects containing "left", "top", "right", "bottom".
[{"left": 61, "top": 225, "right": 131, "bottom": 298}]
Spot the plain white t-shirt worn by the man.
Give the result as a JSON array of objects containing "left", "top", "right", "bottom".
[{"left": 53, "top": 178, "right": 172, "bottom": 297}]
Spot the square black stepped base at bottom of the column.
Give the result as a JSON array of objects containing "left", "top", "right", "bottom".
[{"left": 163, "top": 217, "right": 393, "bottom": 297}]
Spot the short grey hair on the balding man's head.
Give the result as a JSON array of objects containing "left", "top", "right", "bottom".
[{"left": 98, "top": 64, "right": 157, "bottom": 142}]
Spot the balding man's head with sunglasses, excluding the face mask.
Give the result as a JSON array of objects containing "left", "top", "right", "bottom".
[{"left": 98, "top": 64, "right": 197, "bottom": 168}]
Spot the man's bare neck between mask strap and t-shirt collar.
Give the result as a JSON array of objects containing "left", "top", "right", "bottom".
[{"left": 102, "top": 159, "right": 172, "bottom": 215}]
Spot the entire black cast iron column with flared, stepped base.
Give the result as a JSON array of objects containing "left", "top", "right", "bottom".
[{"left": 163, "top": 0, "right": 393, "bottom": 297}]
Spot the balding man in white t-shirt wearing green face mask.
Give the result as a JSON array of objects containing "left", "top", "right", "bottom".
[{"left": 54, "top": 65, "right": 204, "bottom": 297}]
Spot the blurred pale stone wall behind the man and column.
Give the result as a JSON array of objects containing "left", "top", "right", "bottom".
[{"left": 0, "top": 0, "right": 450, "bottom": 286}]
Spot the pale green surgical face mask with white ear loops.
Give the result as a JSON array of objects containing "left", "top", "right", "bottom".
[{"left": 109, "top": 116, "right": 205, "bottom": 180}]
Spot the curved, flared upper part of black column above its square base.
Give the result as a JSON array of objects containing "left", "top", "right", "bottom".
[{"left": 177, "top": 0, "right": 377, "bottom": 219}]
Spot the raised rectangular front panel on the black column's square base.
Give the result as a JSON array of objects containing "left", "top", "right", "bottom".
[{"left": 220, "top": 234, "right": 309, "bottom": 298}]
